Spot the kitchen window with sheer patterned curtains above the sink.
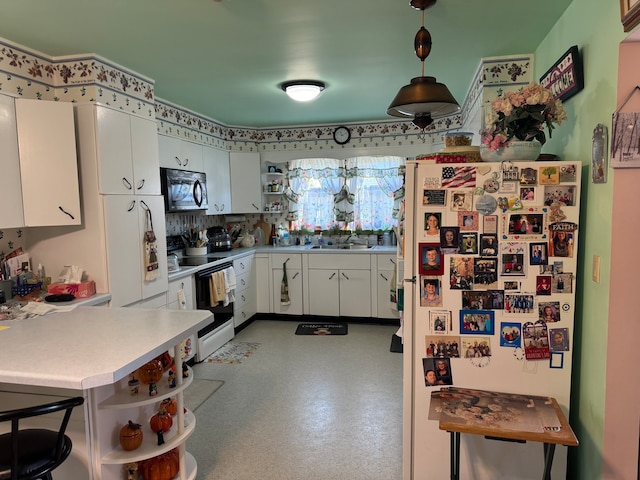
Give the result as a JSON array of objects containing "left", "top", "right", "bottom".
[{"left": 286, "top": 156, "right": 405, "bottom": 231}]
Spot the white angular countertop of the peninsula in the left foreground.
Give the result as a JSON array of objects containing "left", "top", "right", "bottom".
[{"left": 0, "top": 307, "right": 211, "bottom": 390}]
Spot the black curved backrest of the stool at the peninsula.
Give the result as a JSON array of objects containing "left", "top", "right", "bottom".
[{"left": 0, "top": 397, "right": 84, "bottom": 478}]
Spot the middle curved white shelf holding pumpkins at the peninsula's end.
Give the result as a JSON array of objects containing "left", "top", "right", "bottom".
[{"left": 101, "top": 410, "right": 196, "bottom": 465}]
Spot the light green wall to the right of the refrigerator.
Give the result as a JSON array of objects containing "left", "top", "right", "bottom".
[{"left": 535, "top": 0, "right": 626, "bottom": 480}]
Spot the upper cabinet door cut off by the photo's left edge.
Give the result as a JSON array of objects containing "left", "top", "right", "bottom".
[{"left": 0, "top": 95, "right": 24, "bottom": 228}]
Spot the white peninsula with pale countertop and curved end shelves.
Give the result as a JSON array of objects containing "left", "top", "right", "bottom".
[{"left": 0, "top": 307, "right": 211, "bottom": 480}]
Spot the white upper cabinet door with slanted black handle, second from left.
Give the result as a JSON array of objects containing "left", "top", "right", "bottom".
[{"left": 15, "top": 98, "right": 82, "bottom": 227}]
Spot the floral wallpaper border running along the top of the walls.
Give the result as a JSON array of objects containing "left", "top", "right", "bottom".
[{"left": 0, "top": 38, "right": 533, "bottom": 151}]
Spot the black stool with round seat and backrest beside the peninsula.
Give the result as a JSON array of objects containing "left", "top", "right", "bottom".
[{"left": 0, "top": 397, "right": 84, "bottom": 480}]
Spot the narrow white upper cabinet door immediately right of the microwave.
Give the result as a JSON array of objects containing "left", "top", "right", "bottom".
[{"left": 202, "top": 146, "right": 231, "bottom": 215}]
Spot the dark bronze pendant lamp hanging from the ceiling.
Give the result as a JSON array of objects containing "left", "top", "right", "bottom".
[{"left": 387, "top": 0, "right": 460, "bottom": 130}]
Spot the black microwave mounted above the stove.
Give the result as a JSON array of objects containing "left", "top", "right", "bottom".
[{"left": 160, "top": 168, "right": 207, "bottom": 212}]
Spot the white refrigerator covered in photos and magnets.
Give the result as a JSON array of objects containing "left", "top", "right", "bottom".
[{"left": 402, "top": 161, "right": 581, "bottom": 480}]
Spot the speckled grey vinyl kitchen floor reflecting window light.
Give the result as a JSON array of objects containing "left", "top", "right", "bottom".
[{"left": 187, "top": 320, "right": 402, "bottom": 480}]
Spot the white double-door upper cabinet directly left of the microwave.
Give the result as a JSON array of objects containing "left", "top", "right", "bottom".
[{"left": 93, "top": 104, "right": 160, "bottom": 195}]
